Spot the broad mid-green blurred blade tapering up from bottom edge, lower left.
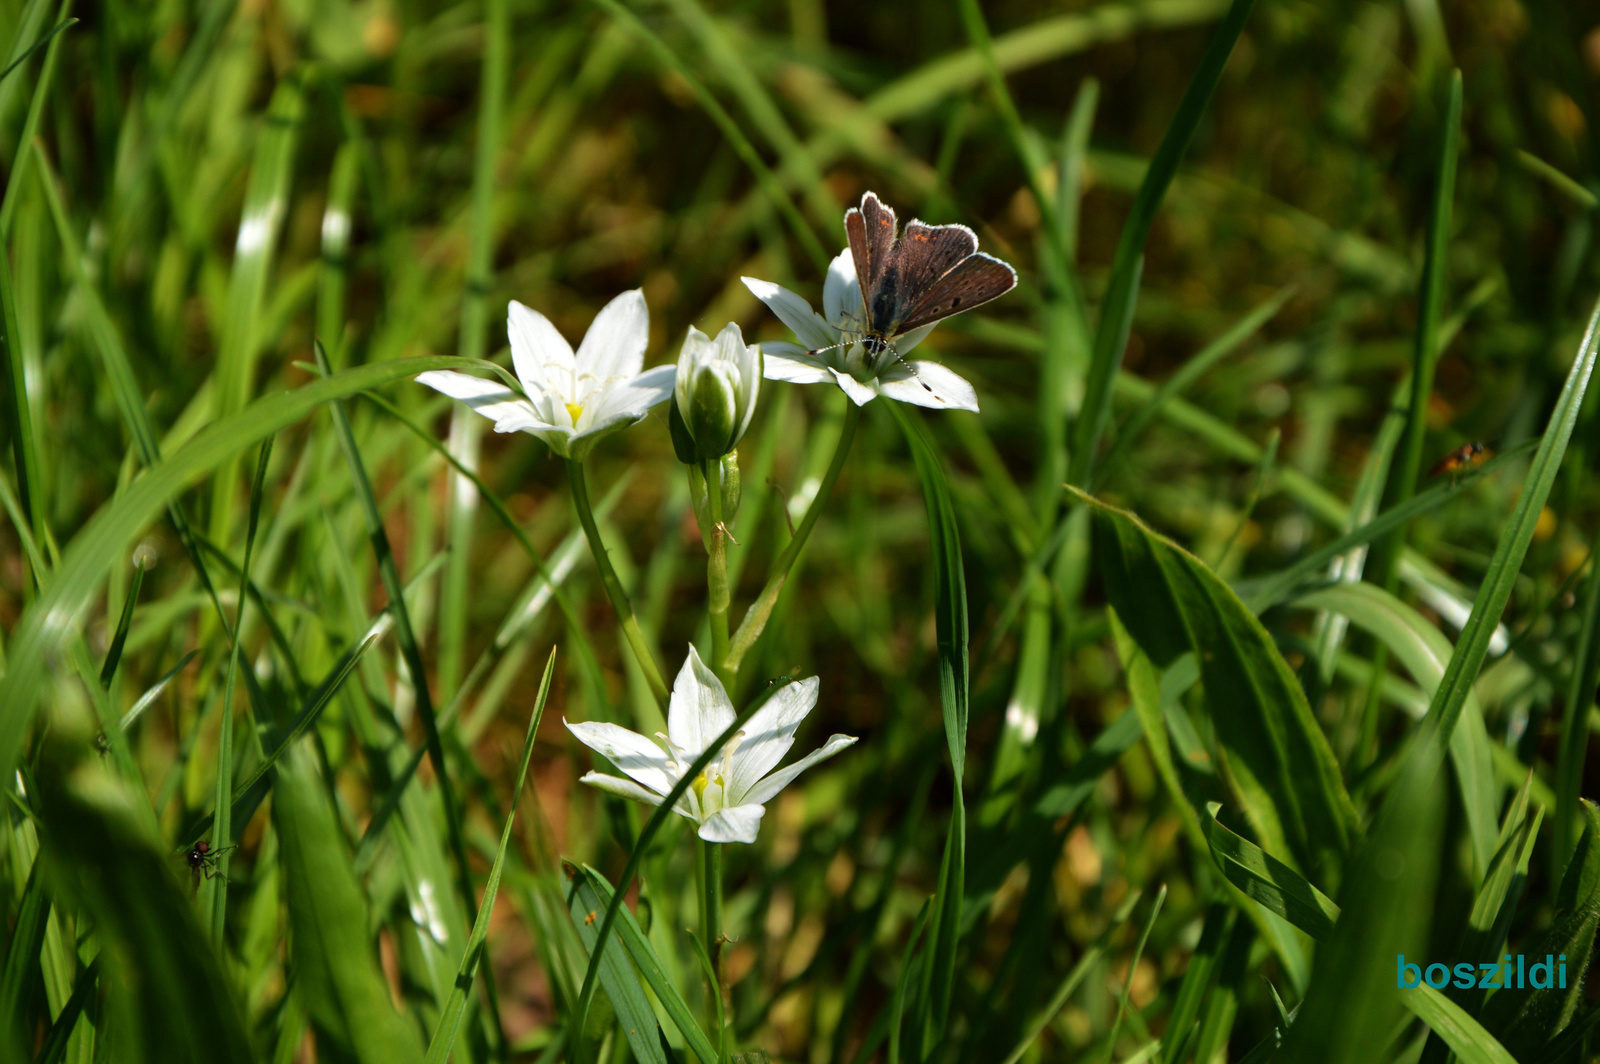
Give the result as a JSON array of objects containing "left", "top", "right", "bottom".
[{"left": 272, "top": 746, "right": 422, "bottom": 1064}]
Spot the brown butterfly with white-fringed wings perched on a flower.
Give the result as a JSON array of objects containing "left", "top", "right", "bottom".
[{"left": 845, "top": 192, "right": 1016, "bottom": 357}]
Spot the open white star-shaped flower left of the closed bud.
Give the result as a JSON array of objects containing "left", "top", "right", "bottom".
[{"left": 416, "top": 288, "right": 677, "bottom": 461}]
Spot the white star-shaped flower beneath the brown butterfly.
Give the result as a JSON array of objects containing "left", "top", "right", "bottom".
[{"left": 741, "top": 248, "right": 978, "bottom": 411}]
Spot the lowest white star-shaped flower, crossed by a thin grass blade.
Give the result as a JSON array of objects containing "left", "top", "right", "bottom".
[{"left": 562, "top": 646, "right": 856, "bottom": 842}]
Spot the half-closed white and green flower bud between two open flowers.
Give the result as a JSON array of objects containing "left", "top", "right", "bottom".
[{"left": 670, "top": 322, "right": 762, "bottom": 462}]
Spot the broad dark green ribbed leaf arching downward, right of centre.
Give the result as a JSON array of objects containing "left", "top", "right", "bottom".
[{"left": 1072, "top": 490, "right": 1360, "bottom": 869}]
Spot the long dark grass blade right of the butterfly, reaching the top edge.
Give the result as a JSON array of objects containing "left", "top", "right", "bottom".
[{"left": 1067, "top": 0, "right": 1254, "bottom": 485}]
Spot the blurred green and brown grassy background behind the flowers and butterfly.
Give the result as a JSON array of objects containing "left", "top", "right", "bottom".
[{"left": 0, "top": 0, "right": 1600, "bottom": 1064}]
